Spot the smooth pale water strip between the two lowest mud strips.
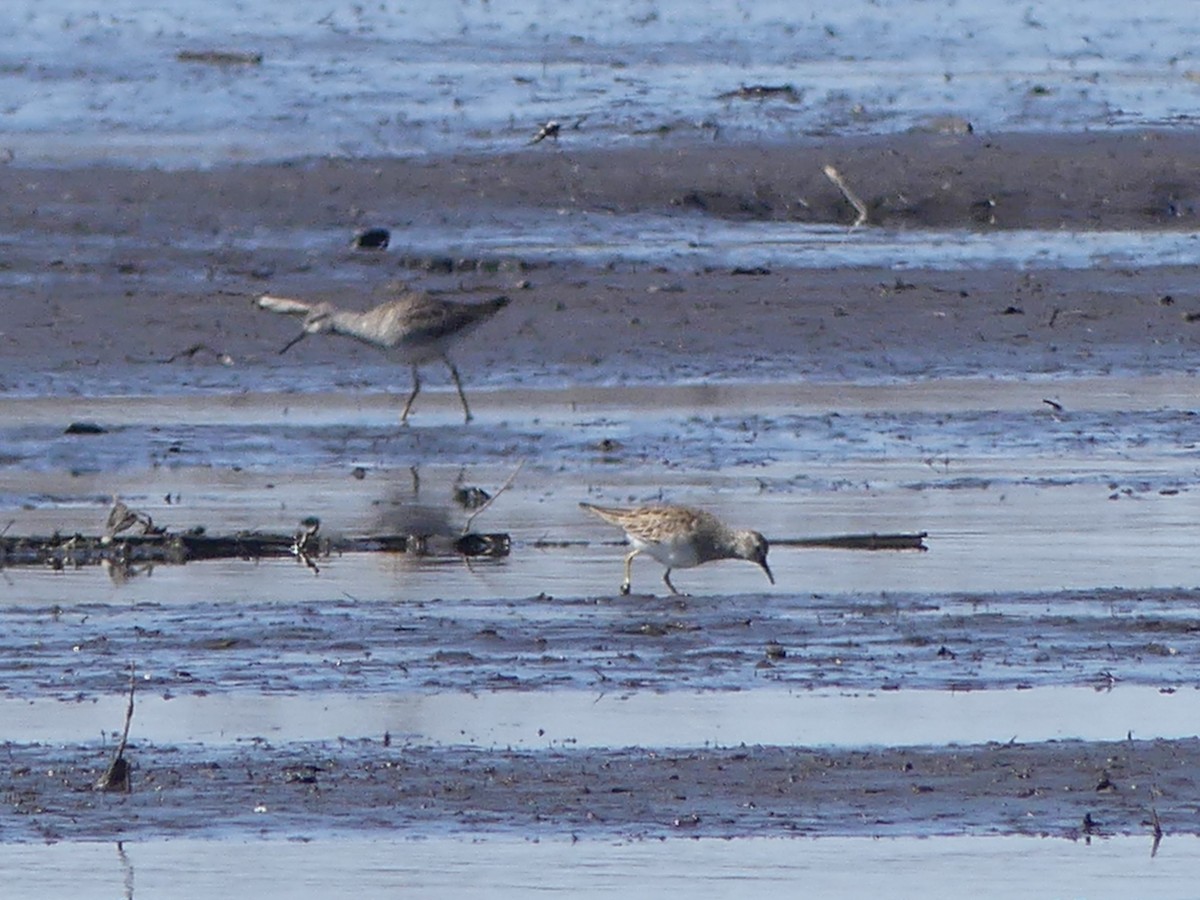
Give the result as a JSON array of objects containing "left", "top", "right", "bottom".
[{"left": 0, "top": 686, "right": 1200, "bottom": 750}]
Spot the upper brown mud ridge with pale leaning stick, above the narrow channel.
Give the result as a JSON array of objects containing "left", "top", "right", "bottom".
[{"left": 7, "top": 130, "right": 1200, "bottom": 232}]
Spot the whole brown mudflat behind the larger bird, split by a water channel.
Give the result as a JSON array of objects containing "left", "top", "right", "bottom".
[{"left": 7, "top": 132, "right": 1200, "bottom": 396}]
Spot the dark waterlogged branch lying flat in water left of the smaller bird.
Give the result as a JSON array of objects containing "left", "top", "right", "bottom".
[{"left": 0, "top": 532, "right": 511, "bottom": 569}]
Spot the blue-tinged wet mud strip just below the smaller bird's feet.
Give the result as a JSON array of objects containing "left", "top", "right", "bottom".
[{"left": 7, "top": 588, "right": 1200, "bottom": 700}]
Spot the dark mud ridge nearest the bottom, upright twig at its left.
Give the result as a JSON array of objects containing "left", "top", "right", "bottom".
[{"left": 7, "top": 739, "right": 1200, "bottom": 854}]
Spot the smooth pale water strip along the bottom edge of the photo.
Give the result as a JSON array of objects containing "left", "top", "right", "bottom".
[{"left": 0, "top": 835, "right": 1195, "bottom": 900}]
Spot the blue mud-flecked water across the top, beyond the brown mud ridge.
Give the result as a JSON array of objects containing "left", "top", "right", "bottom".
[{"left": 7, "top": 0, "right": 1200, "bottom": 166}]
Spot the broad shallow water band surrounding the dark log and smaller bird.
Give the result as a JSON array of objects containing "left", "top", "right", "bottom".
[{"left": 0, "top": 376, "right": 1200, "bottom": 605}]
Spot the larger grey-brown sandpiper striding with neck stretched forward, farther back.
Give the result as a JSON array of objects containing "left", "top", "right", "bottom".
[{"left": 258, "top": 292, "right": 509, "bottom": 422}]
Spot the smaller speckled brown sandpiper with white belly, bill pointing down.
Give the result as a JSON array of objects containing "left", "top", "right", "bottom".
[{"left": 580, "top": 503, "right": 775, "bottom": 594}]
